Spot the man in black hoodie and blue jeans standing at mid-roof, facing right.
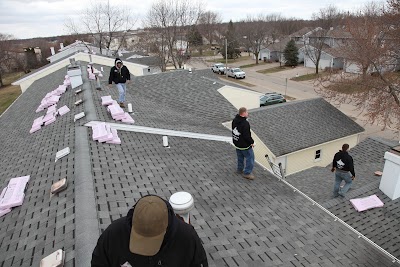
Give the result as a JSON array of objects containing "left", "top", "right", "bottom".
[{"left": 232, "top": 107, "right": 255, "bottom": 180}]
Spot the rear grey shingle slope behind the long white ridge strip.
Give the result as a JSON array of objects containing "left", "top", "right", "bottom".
[{"left": 93, "top": 68, "right": 237, "bottom": 136}]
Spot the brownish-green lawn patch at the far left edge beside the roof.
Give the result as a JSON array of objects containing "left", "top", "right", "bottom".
[{"left": 0, "top": 72, "right": 25, "bottom": 114}]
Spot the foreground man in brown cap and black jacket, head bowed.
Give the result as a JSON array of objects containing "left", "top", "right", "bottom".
[{"left": 92, "top": 195, "right": 208, "bottom": 267}]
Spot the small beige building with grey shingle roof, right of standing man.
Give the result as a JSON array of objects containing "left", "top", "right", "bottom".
[{"left": 249, "top": 98, "right": 364, "bottom": 175}]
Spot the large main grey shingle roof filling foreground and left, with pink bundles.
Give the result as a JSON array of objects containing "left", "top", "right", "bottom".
[{"left": 0, "top": 62, "right": 398, "bottom": 266}]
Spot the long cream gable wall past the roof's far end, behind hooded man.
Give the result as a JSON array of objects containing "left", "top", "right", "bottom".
[{"left": 12, "top": 52, "right": 148, "bottom": 93}]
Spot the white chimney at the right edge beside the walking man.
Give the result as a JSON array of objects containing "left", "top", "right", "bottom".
[{"left": 379, "top": 149, "right": 400, "bottom": 200}]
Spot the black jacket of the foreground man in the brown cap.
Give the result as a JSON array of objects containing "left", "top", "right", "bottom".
[{"left": 92, "top": 198, "right": 208, "bottom": 267}]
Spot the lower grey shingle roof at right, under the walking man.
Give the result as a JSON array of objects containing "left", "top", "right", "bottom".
[{"left": 287, "top": 138, "right": 400, "bottom": 258}]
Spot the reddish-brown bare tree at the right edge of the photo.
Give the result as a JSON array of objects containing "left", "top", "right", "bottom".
[{"left": 318, "top": 1, "right": 400, "bottom": 130}]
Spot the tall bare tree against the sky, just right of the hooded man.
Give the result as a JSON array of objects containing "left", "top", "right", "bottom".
[{"left": 145, "top": 0, "right": 202, "bottom": 71}]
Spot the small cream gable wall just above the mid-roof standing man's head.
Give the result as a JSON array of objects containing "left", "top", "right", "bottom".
[{"left": 218, "top": 86, "right": 262, "bottom": 109}]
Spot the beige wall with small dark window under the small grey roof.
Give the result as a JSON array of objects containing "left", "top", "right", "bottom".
[{"left": 279, "top": 134, "right": 359, "bottom": 175}]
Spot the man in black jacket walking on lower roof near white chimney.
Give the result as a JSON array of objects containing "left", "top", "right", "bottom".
[{"left": 331, "top": 144, "right": 356, "bottom": 197}]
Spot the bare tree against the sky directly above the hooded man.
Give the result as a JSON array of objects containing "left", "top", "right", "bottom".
[{"left": 65, "top": 1, "right": 136, "bottom": 53}]
